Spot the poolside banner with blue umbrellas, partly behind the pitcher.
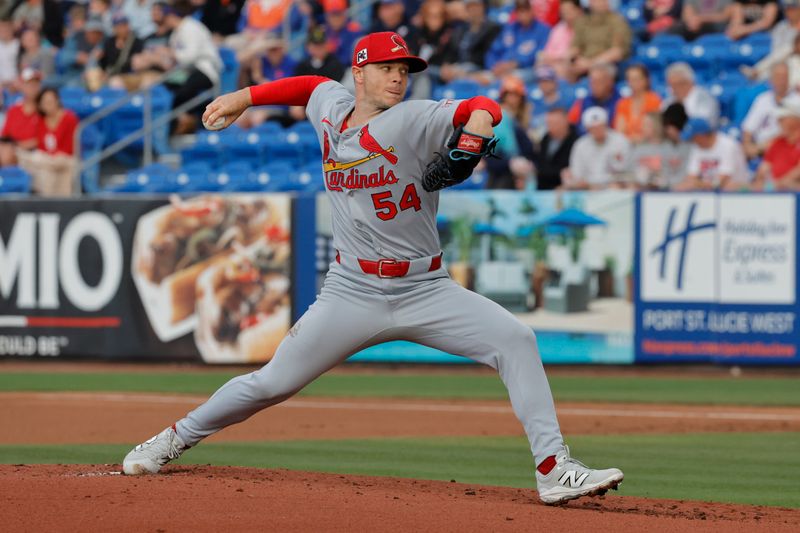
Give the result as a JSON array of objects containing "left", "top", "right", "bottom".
[{"left": 317, "top": 191, "right": 634, "bottom": 364}]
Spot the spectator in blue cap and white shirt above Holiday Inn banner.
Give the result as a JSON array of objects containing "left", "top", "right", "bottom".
[{"left": 674, "top": 115, "right": 748, "bottom": 191}]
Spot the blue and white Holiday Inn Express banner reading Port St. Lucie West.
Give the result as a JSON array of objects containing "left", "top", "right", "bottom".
[{"left": 635, "top": 193, "right": 800, "bottom": 364}]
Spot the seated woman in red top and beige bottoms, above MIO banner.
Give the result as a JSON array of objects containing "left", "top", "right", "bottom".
[{"left": 19, "top": 88, "right": 78, "bottom": 196}]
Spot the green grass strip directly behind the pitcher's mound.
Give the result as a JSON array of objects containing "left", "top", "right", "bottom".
[{"left": 0, "top": 433, "right": 800, "bottom": 508}]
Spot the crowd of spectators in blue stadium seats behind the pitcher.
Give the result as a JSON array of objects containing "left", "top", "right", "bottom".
[{"left": 0, "top": 0, "right": 800, "bottom": 195}]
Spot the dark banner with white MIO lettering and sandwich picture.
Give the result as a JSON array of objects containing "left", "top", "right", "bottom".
[{"left": 0, "top": 195, "right": 292, "bottom": 363}]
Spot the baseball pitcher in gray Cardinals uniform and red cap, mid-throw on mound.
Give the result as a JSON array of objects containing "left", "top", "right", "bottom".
[{"left": 123, "top": 32, "right": 623, "bottom": 504}]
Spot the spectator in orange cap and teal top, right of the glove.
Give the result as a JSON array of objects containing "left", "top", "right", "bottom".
[{"left": 486, "top": 76, "right": 534, "bottom": 190}]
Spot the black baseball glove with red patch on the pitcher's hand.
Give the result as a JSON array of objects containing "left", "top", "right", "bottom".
[{"left": 422, "top": 126, "right": 497, "bottom": 192}]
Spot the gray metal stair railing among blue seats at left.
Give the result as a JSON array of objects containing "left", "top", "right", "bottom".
[{"left": 73, "top": 66, "right": 221, "bottom": 194}]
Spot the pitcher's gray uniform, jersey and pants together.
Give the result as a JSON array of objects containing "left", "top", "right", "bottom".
[{"left": 175, "top": 82, "right": 563, "bottom": 463}]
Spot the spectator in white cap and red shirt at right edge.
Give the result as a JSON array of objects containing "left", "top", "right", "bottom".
[{"left": 754, "top": 100, "right": 800, "bottom": 191}]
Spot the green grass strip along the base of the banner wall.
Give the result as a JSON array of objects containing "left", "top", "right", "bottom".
[{"left": 0, "top": 372, "right": 800, "bottom": 406}]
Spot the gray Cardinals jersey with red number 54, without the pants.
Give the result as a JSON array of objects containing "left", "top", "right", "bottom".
[{"left": 306, "top": 81, "right": 458, "bottom": 259}]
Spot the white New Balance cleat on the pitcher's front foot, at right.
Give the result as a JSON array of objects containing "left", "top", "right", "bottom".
[{"left": 536, "top": 446, "right": 625, "bottom": 505}]
